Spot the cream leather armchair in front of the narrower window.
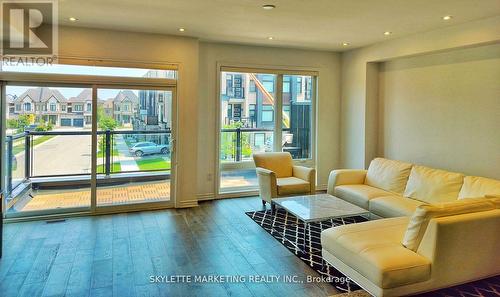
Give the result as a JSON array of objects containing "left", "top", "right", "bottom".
[{"left": 253, "top": 152, "right": 316, "bottom": 211}]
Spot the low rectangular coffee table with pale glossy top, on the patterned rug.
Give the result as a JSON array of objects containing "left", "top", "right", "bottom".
[{"left": 271, "top": 194, "right": 370, "bottom": 251}]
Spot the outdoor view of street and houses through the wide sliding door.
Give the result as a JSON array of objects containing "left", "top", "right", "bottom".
[{"left": 5, "top": 70, "right": 175, "bottom": 212}]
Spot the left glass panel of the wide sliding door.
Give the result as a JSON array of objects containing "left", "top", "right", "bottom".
[{"left": 4, "top": 83, "right": 92, "bottom": 215}]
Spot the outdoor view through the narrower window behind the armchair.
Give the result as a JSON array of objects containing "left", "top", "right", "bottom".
[{"left": 220, "top": 72, "right": 313, "bottom": 192}]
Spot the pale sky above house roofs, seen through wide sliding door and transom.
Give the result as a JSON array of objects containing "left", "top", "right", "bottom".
[{"left": 0, "top": 64, "right": 164, "bottom": 100}]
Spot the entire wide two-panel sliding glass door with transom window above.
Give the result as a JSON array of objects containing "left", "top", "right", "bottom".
[{"left": 0, "top": 65, "right": 177, "bottom": 218}]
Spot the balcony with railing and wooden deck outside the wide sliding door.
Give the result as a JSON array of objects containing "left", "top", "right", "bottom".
[{"left": 6, "top": 129, "right": 171, "bottom": 213}]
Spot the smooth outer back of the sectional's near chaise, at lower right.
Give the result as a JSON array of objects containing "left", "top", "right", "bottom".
[{"left": 417, "top": 209, "right": 500, "bottom": 284}]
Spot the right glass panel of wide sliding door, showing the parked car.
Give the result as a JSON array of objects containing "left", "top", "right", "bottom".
[{"left": 96, "top": 88, "right": 175, "bottom": 207}]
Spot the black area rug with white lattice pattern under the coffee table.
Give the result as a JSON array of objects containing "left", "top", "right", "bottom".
[{"left": 246, "top": 209, "right": 500, "bottom": 297}]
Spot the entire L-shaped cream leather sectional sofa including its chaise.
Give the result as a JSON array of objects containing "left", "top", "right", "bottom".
[{"left": 321, "top": 159, "right": 500, "bottom": 296}]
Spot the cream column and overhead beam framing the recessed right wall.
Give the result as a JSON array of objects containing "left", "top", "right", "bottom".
[{"left": 340, "top": 17, "right": 500, "bottom": 168}]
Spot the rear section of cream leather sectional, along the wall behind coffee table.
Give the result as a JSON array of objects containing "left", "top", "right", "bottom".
[{"left": 327, "top": 158, "right": 500, "bottom": 218}]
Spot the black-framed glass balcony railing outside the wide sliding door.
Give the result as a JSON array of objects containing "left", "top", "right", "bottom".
[{"left": 6, "top": 129, "right": 171, "bottom": 204}]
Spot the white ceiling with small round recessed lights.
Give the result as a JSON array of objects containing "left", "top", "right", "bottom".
[{"left": 59, "top": 0, "right": 500, "bottom": 50}]
